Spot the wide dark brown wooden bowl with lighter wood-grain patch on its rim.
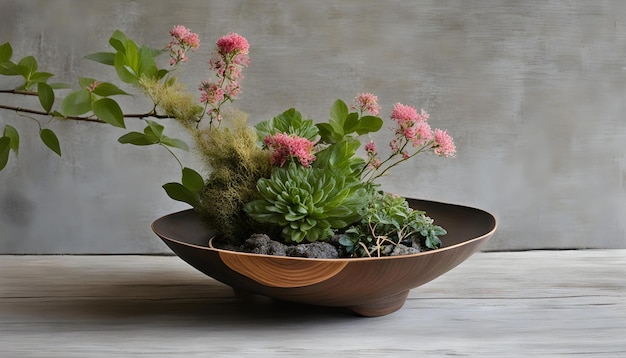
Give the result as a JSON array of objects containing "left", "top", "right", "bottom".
[{"left": 152, "top": 199, "right": 497, "bottom": 316}]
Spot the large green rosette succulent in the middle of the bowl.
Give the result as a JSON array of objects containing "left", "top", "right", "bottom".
[{"left": 244, "top": 163, "right": 369, "bottom": 243}]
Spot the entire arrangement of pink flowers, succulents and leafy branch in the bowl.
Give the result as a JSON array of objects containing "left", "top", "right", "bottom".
[{"left": 0, "top": 26, "right": 456, "bottom": 257}]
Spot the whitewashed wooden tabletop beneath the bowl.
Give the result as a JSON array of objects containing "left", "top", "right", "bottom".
[{"left": 0, "top": 250, "right": 626, "bottom": 358}]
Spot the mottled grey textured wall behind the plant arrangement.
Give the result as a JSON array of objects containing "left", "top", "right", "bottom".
[{"left": 0, "top": 0, "right": 626, "bottom": 253}]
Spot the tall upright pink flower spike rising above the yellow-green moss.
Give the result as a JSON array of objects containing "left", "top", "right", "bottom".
[{"left": 198, "top": 33, "right": 250, "bottom": 122}]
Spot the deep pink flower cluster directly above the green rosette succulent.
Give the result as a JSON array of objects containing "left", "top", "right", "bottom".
[{"left": 263, "top": 133, "right": 315, "bottom": 168}]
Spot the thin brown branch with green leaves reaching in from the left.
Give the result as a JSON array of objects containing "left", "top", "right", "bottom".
[{"left": 0, "top": 31, "right": 199, "bottom": 205}]
